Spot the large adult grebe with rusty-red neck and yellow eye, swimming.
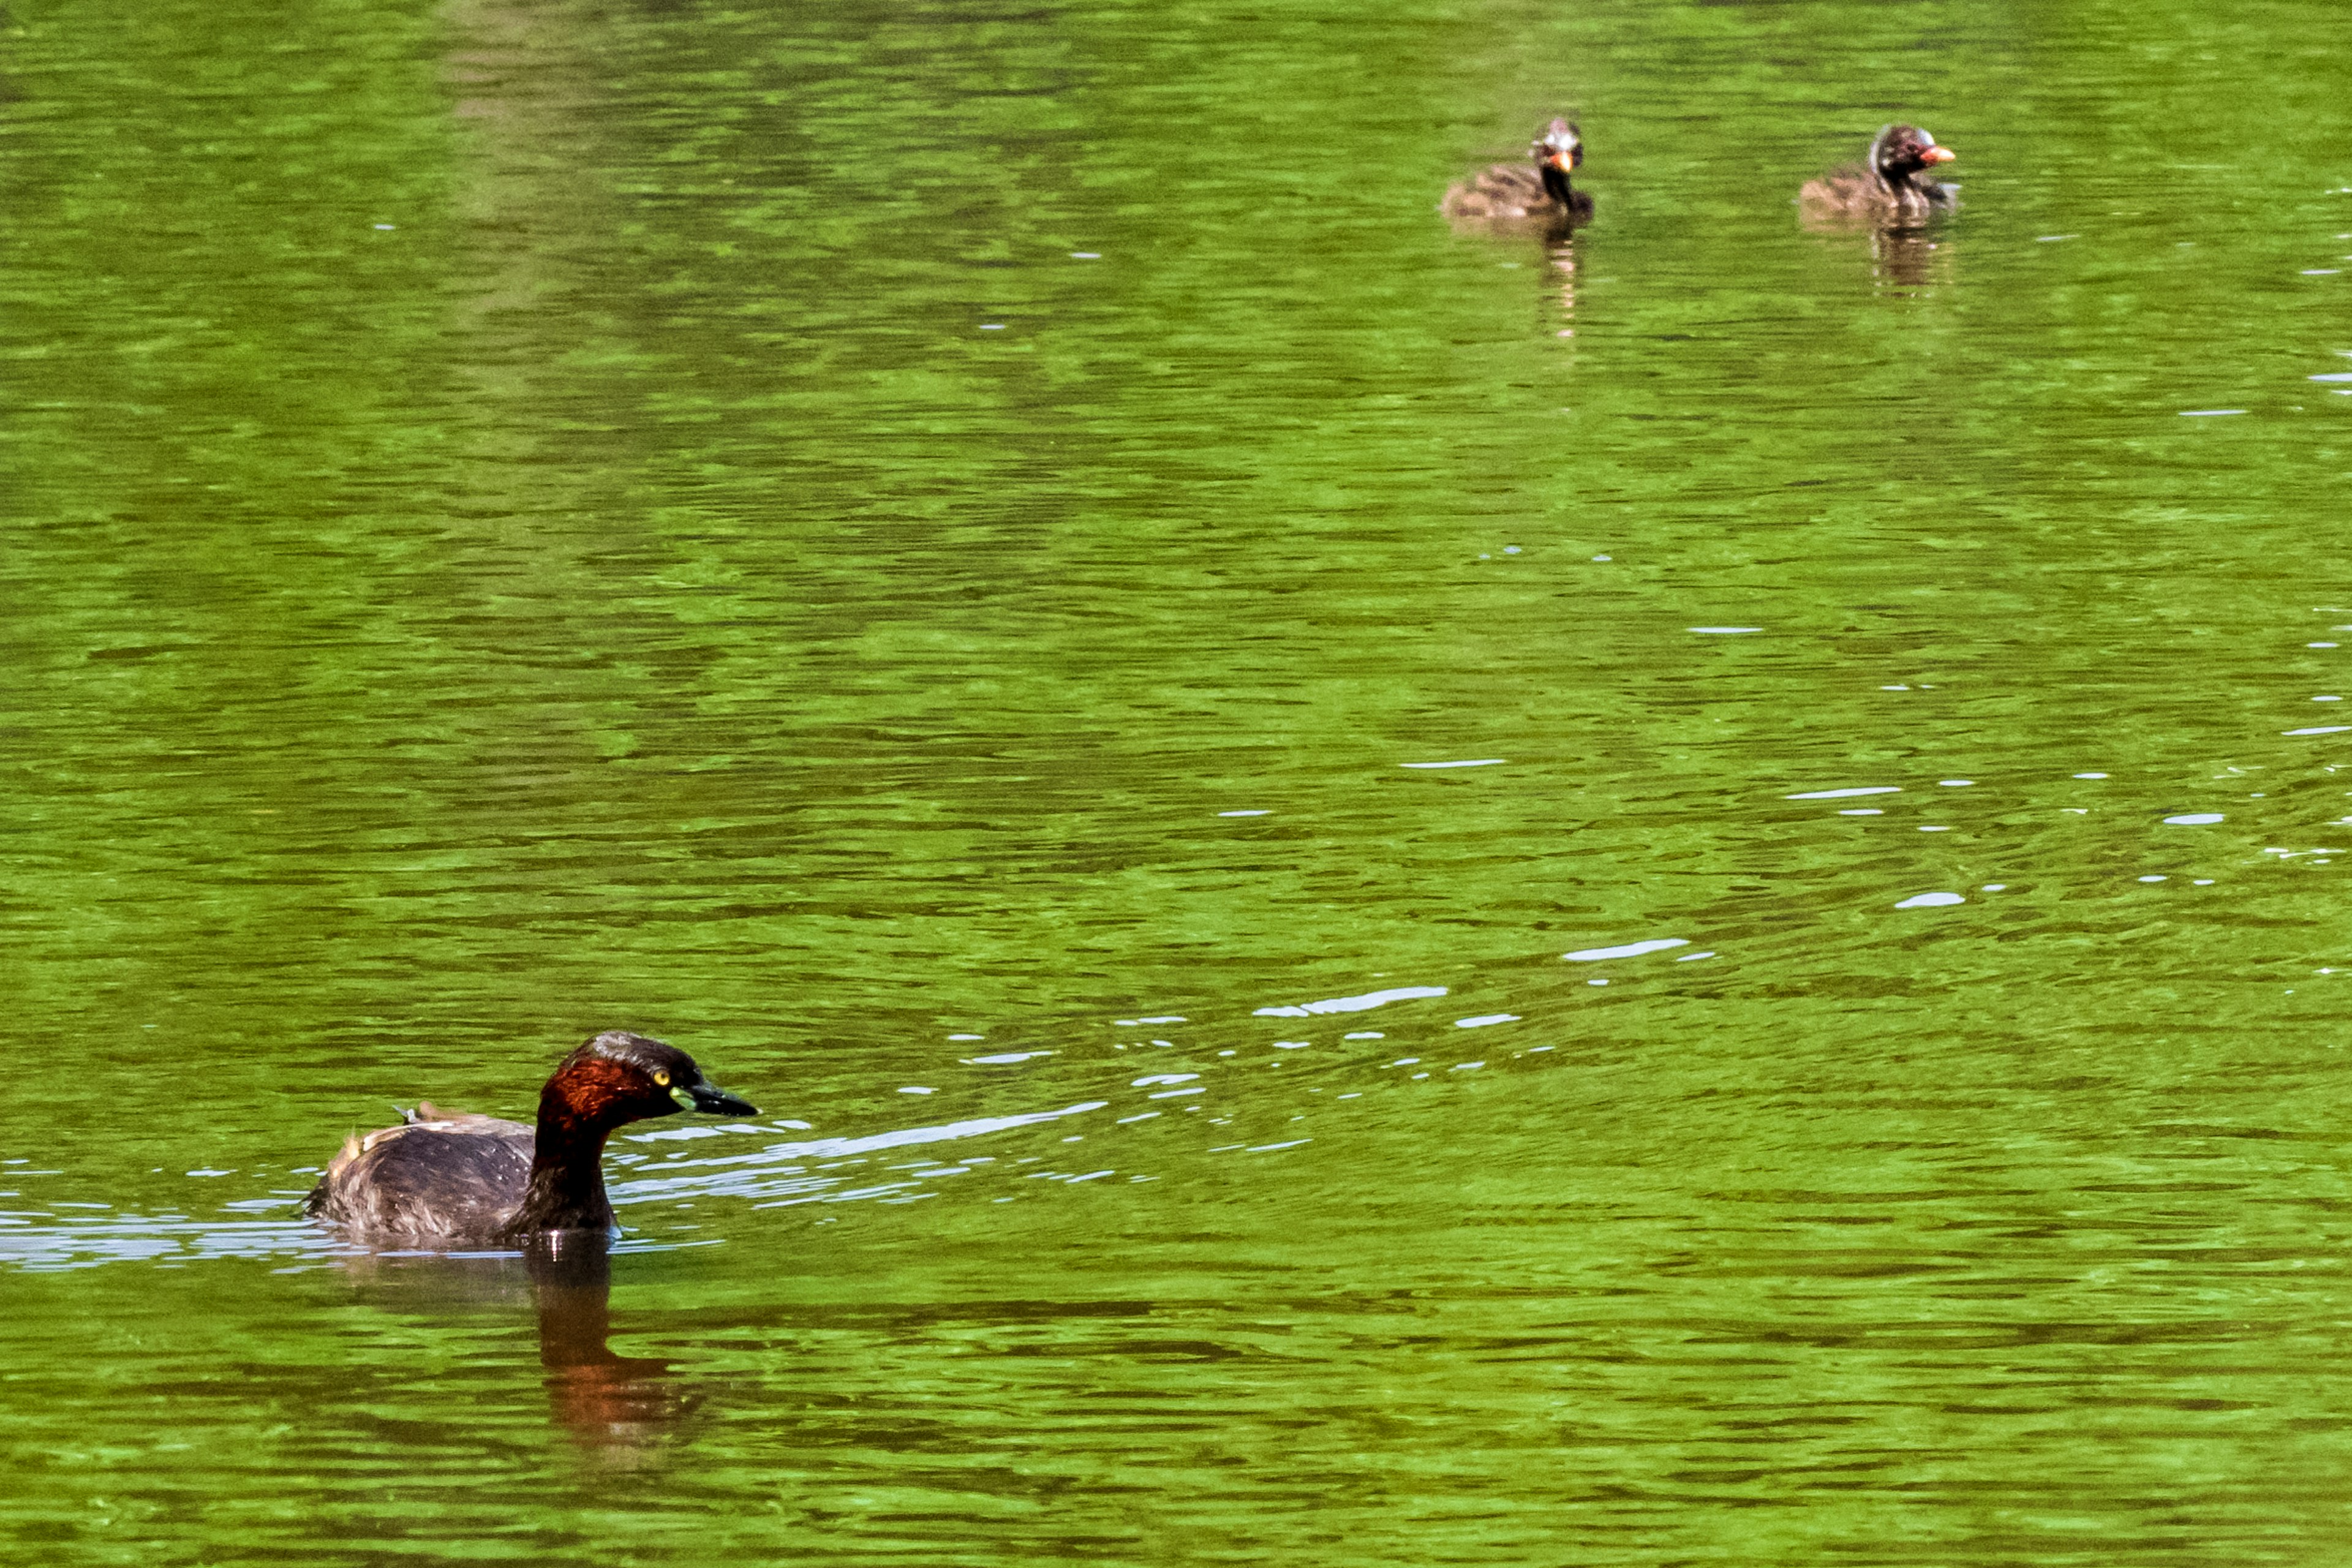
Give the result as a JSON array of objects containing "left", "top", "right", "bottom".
[{"left": 303, "top": 1030, "right": 760, "bottom": 1243}]
